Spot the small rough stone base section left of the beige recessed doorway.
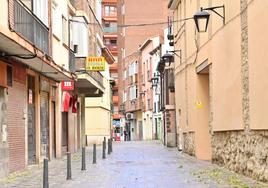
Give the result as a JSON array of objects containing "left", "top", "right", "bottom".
[{"left": 183, "top": 132, "right": 195, "bottom": 156}]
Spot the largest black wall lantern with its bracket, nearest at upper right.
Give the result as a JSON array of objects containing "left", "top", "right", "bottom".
[{"left": 194, "top": 5, "right": 225, "bottom": 33}]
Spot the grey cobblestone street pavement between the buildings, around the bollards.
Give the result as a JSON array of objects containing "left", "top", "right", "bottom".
[{"left": 0, "top": 141, "right": 268, "bottom": 188}]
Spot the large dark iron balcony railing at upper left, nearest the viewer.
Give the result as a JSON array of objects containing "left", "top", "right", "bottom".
[{"left": 13, "top": 0, "right": 49, "bottom": 54}]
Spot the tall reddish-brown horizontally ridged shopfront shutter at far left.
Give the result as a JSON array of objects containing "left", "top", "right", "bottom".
[{"left": 7, "top": 81, "right": 26, "bottom": 172}]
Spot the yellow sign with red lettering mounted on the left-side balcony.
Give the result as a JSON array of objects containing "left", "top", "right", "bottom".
[{"left": 86, "top": 57, "right": 105, "bottom": 71}]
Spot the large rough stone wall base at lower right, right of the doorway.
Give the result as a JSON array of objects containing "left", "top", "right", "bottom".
[{"left": 212, "top": 131, "right": 268, "bottom": 181}]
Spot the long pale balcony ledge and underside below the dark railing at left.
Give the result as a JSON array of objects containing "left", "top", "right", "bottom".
[{"left": 0, "top": 28, "right": 75, "bottom": 81}]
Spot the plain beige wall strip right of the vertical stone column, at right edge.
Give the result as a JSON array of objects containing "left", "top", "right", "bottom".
[{"left": 248, "top": 0, "right": 268, "bottom": 129}]
